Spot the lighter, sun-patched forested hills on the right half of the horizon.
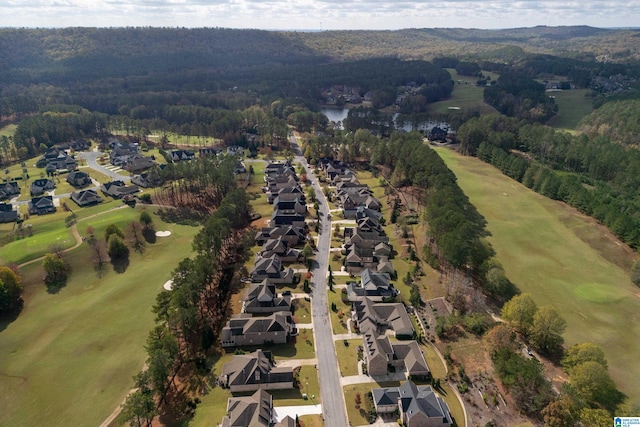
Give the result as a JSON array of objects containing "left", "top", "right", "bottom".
[{"left": 289, "top": 26, "right": 640, "bottom": 62}]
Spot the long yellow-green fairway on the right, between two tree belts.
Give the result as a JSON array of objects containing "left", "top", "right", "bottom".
[{"left": 438, "top": 149, "right": 640, "bottom": 405}]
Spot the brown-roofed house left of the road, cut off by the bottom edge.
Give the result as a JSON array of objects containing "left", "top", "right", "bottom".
[{"left": 218, "top": 390, "right": 295, "bottom": 427}]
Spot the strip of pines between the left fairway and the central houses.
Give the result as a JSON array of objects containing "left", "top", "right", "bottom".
[{"left": 118, "top": 189, "right": 250, "bottom": 426}]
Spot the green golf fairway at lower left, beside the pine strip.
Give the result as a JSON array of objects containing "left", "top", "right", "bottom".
[{"left": 0, "top": 209, "right": 197, "bottom": 426}]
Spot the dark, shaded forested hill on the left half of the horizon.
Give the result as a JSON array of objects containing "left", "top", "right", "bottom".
[{"left": 0, "top": 28, "right": 328, "bottom": 83}]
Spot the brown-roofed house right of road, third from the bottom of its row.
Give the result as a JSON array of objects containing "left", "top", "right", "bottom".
[{"left": 353, "top": 297, "right": 415, "bottom": 340}]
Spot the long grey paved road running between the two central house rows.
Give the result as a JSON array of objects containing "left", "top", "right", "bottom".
[{"left": 291, "top": 136, "right": 349, "bottom": 427}]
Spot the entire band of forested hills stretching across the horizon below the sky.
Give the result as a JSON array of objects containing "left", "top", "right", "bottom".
[{"left": 0, "top": 26, "right": 640, "bottom": 84}]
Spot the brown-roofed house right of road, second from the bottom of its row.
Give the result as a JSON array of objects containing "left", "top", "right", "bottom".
[{"left": 362, "top": 331, "right": 431, "bottom": 378}]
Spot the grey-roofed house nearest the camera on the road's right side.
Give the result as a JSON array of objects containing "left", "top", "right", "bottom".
[{"left": 371, "top": 381, "right": 453, "bottom": 427}]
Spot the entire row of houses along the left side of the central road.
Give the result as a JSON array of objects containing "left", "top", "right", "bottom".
[{"left": 219, "top": 163, "right": 307, "bottom": 427}]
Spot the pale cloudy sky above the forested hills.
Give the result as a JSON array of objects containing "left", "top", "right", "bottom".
[{"left": 0, "top": 0, "right": 640, "bottom": 30}]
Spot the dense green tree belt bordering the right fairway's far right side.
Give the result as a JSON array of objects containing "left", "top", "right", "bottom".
[{"left": 458, "top": 116, "right": 640, "bottom": 249}]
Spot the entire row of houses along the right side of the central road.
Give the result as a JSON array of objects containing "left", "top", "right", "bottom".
[{"left": 320, "top": 160, "right": 453, "bottom": 427}]
